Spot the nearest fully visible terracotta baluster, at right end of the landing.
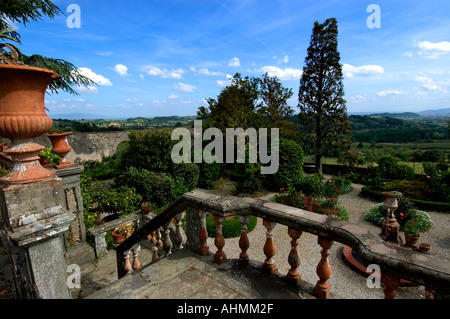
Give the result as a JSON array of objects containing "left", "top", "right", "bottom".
[{"left": 314, "top": 236, "right": 333, "bottom": 299}]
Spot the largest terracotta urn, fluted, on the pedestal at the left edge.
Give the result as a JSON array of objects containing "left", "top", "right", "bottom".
[{"left": 0, "top": 64, "right": 61, "bottom": 184}]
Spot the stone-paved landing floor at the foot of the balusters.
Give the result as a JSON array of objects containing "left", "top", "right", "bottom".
[{"left": 87, "top": 249, "right": 314, "bottom": 299}]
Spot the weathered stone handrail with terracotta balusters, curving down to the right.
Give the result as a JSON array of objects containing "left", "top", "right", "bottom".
[{"left": 116, "top": 190, "right": 450, "bottom": 298}]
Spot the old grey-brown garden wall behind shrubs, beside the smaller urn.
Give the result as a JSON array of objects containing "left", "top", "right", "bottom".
[{"left": 36, "top": 131, "right": 130, "bottom": 163}]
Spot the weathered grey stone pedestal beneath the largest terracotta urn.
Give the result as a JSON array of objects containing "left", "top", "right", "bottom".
[{"left": 0, "top": 177, "right": 74, "bottom": 299}]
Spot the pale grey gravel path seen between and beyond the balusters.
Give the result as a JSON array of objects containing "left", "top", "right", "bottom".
[{"left": 208, "top": 180, "right": 450, "bottom": 299}]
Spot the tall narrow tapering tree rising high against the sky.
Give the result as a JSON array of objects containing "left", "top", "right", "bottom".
[{"left": 298, "top": 18, "right": 351, "bottom": 173}]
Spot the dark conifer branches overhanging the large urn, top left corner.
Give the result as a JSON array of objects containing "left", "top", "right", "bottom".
[{"left": 0, "top": 0, "right": 95, "bottom": 95}]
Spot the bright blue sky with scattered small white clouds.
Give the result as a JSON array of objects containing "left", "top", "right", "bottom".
[{"left": 9, "top": 0, "right": 450, "bottom": 117}]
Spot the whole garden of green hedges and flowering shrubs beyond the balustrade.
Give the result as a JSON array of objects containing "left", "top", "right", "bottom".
[{"left": 70, "top": 124, "right": 450, "bottom": 251}]
